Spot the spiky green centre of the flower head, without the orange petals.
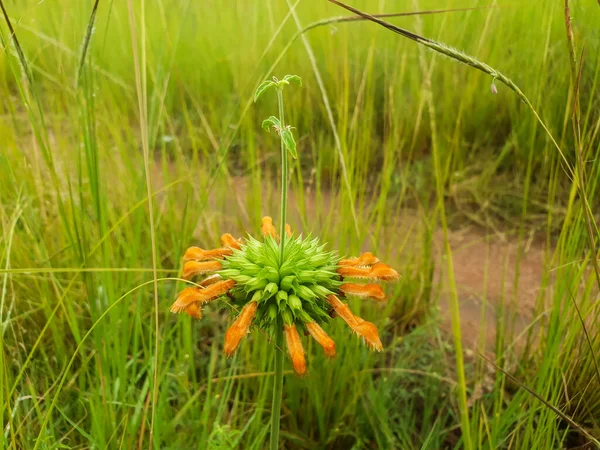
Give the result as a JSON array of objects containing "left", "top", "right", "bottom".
[{"left": 217, "top": 235, "right": 342, "bottom": 335}]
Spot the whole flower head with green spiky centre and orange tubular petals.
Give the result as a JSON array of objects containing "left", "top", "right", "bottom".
[{"left": 171, "top": 216, "right": 399, "bottom": 375}]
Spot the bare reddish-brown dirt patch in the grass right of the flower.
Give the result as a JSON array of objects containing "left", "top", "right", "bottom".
[{"left": 435, "top": 228, "right": 544, "bottom": 350}]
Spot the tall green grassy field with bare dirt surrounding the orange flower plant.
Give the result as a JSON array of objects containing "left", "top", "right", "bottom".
[{"left": 0, "top": 0, "right": 600, "bottom": 450}]
